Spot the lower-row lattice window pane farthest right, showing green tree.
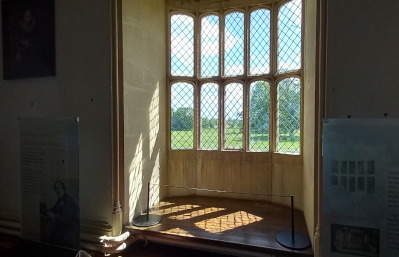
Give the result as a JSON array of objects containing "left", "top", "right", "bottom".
[{"left": 277, "top": 78, "right": 301, "bottom": 154}]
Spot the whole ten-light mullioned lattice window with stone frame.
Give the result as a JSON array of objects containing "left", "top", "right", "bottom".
[{"left": 168, "top": 0, "right": 303, "bottom": 154}]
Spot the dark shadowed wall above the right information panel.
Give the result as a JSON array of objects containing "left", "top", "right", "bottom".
[{"left": 326, "top": 0, "right": 399, "bottom": 118}]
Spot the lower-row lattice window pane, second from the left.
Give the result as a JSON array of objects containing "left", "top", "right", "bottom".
[{"left": 201, "top": 83, "right": 219, "bottom": 150}]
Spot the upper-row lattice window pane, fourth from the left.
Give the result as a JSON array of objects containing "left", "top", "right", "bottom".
[{"left": 249, "top": 9, "right": 270, "bottom": 75}]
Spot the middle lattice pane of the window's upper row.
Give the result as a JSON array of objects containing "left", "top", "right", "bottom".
[{"left": 224, "top": 12, "right": 244, "bottom": 77}]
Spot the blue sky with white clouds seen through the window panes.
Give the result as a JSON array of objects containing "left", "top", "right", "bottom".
[{"left": 171, "top": 0, "right": 301, "bottom": 118}]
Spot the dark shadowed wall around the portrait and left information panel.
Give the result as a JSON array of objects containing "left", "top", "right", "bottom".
[{"left": 0, "top": 0, "right": 112, "bottom": 223}]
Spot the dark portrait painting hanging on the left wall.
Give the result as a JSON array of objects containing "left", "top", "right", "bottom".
[{"left": 2, "top": 0, "right": 55, "bottom": 80}]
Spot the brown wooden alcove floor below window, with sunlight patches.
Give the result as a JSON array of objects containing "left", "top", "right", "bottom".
[{"left": 126, "top": 196, "right": 313, "bottom": 256}]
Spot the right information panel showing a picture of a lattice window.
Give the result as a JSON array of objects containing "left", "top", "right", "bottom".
[{"left": 322, "top": 119, "right": 399, "bottom": 257}]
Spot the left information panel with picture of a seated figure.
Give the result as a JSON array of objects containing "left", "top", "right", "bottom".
[{"left": 19, "top": 118, "right": 80, "bottom": 249}]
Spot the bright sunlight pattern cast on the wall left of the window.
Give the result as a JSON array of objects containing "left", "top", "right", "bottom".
[{"left": 128, "top": 82, "right": 161, "bottom": 221}]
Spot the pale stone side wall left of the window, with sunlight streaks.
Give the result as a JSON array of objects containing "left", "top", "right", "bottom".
[{"left": 122, "top": 0, "right": 167, "bottom": 223}]
